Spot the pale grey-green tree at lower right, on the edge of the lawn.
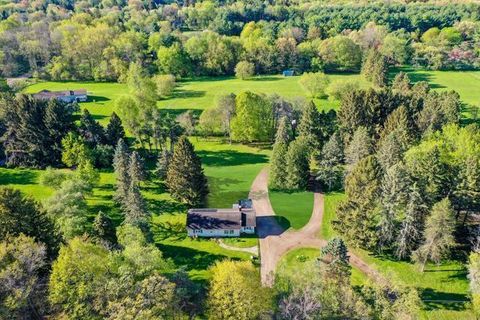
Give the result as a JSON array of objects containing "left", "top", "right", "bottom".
[{"left": 413, "top": 198, "right": 455, "bottom": 272}]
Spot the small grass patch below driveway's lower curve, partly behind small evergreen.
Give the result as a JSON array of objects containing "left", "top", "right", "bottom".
[{"left": 277, "top": 248, "right": 366, "bottom": 286}]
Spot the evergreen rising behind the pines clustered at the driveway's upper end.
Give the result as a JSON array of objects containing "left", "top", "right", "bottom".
[{"left": 297, "top": 102, "right": 324, "bottom": 152}]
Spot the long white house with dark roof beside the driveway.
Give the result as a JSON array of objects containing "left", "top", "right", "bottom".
[{"left": 187, "top": 199, "right": 257, "bottom": 237}]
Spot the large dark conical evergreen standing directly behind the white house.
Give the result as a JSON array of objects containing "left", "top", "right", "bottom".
[{"left": 166, "top": 136, "right": 208, "bottom": 206}]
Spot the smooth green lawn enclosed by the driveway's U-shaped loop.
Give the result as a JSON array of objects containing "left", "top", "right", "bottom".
[{"left": 269, "top": 191, "right": 313, "bottom": 229}]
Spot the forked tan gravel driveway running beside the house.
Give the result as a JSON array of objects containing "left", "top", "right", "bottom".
[{"left": 250, "top": 168, "right": 381, "bottom": 286}]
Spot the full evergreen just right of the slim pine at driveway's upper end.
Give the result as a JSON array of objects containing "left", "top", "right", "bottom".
[{"left": 286, "top": 137, "right": 310, "bottom": 190}]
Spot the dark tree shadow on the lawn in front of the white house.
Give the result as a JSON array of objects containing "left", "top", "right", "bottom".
[{"left": 157, "top": 244, "right": 241, "bottom": 271}]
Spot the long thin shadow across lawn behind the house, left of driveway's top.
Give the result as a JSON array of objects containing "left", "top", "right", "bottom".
[{"left": 197, "top": 150, "right": 268, "bottom": 167}]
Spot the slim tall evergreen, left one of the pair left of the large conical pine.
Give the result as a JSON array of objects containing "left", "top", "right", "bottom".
[{"left": 113, "top": 139, "right": 130, "bottom": 205}]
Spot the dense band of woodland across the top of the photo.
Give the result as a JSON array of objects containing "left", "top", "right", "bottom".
[{"left": 0, "top": 1, "right": 480, "bottom": 82}]
